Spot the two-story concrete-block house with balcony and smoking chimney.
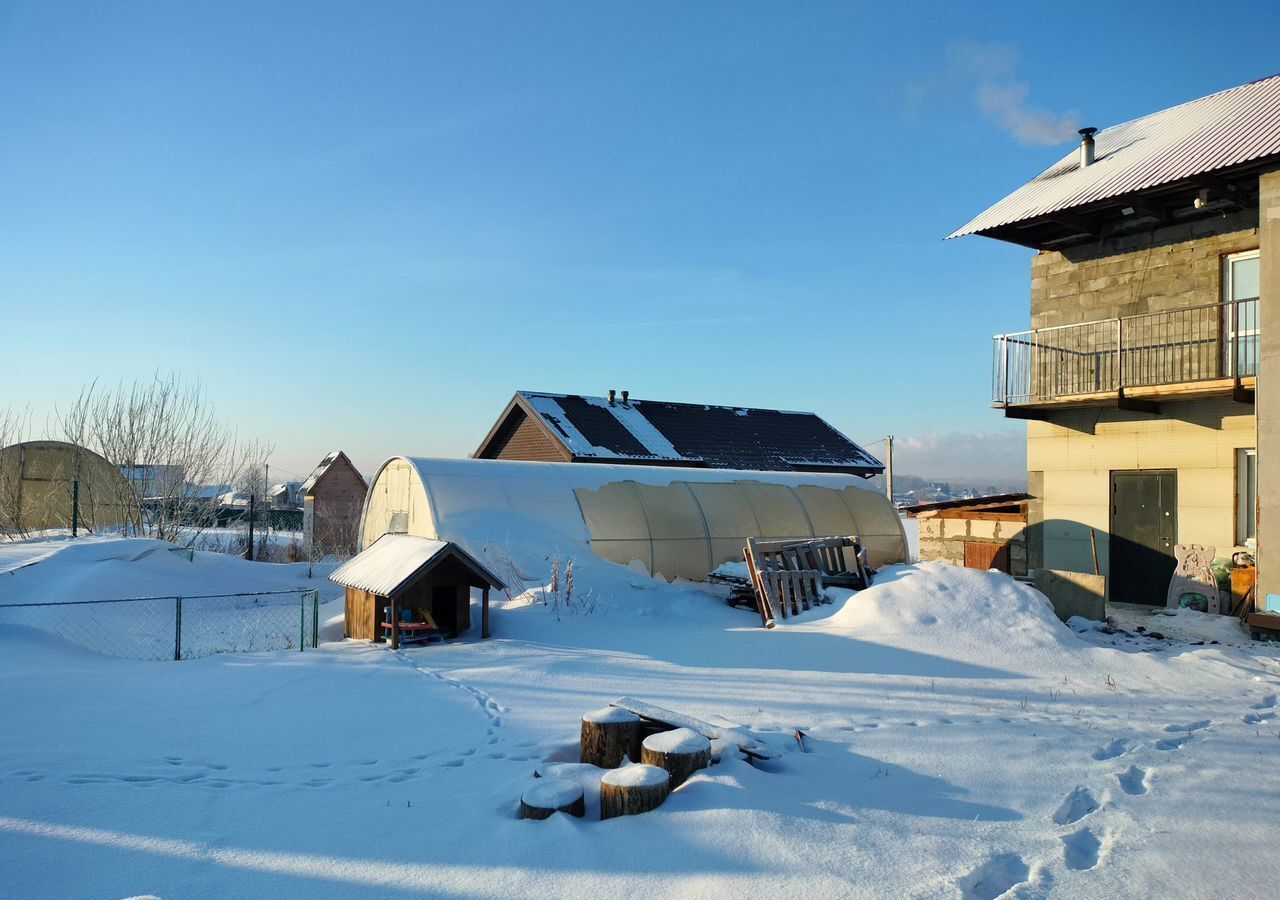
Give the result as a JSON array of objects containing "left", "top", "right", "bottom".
[{"left": 951, "top": 76, "right": 1280, "bottom": 619}]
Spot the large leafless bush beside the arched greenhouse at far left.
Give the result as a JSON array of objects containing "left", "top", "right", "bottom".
[{"left": 59, "top": 373, "right": 271, "bottom": 544}]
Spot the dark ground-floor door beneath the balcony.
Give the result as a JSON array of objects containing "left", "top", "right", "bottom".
[{"left": 1107, "top": 471, "right": 1178, "bottom": 607}]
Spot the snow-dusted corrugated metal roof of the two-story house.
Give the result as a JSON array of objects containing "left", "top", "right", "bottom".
[{"left": 948, "top": 76, "right": 1280, "bottom": 238}]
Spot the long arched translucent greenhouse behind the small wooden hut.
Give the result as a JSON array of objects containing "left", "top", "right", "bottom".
[{"left": 360, "top": 457, "right": 909, "bottom": 581}]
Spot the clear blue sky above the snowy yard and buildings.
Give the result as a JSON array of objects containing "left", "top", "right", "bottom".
[{"left": 0, "top": 0, "right": 1280, "bottom": 486}]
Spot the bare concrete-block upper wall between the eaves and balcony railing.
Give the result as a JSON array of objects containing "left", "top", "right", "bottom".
[{"left": 1032, "top": 210, "right": 1258, "bottom": 328}]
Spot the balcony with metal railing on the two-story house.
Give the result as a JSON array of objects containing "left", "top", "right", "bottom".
[{"left": 992, "top": 298, "right": 1258, "bottom": 419}]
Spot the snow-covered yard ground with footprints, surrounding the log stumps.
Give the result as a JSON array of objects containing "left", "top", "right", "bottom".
[{"left": 0, "top": 537, "right": 1280, "bottom": 897}]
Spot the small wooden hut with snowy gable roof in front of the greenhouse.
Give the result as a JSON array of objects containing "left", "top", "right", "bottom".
[{"left": 329, "top": 534, "right": 503, "bottom": 648}]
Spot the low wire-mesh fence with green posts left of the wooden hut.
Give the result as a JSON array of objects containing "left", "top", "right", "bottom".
[{"left": 0, "top": 588, "right": 320, "bottom": 659}]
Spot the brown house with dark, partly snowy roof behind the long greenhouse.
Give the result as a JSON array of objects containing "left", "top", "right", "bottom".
[{"left": 472, "top": 390, "right": 884, "bottom": 478}]
